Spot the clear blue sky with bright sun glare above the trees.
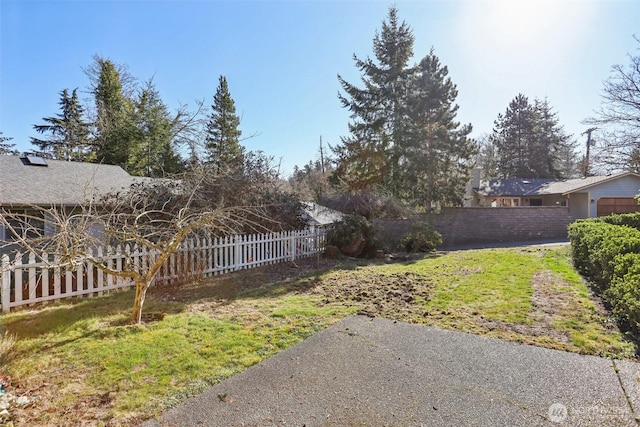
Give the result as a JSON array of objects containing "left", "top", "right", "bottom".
[{"left": 0, "top": 0, "right": 640, "bottom": 175}]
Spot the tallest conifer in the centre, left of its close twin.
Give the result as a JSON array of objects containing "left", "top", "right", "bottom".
[{"left": 334, "top": 7, "right": 414, "bottom": 194}]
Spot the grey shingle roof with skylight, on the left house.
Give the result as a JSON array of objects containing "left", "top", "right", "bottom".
[{"left": 0, "top": 156, "right": 148, "bottom": 206}]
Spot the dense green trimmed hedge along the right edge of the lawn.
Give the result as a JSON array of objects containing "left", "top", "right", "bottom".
[{"left": 569, "top": 214, "right": 640, "bottom": 334}]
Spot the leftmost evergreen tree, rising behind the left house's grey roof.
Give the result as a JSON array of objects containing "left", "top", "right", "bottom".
[{"left": 31, "top": 89, "right": 90, "bottom": 161}]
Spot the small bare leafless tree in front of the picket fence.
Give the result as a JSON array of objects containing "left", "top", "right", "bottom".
[{"left": 0, "top": 166, "right": 302, "bottom": 323}]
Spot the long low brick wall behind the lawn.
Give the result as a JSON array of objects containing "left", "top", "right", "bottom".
[{"left": 375, "top": 206, "right": 574, "bottom": 250}]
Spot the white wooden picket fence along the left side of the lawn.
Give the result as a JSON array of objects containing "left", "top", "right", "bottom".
[{"left": 0, "top": 229, "right": 325, "bottom": 312}]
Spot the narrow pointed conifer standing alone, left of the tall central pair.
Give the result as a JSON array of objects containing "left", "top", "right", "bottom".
[{"left": 205, "top": 76, "right": 243, "bottom": 173}]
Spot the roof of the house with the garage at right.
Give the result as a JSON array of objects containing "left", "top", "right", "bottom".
[{"left": 475, "top": 172, "right": 640, "bottom": 197}]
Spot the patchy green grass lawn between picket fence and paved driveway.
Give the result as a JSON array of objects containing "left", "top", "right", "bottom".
[{"left": 0, "top": 242, "right": 636, "bottom": 426}]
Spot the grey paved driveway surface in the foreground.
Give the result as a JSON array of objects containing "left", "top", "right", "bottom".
[{"left": 144, "top": 316, "right": 640, "bottom": 427}]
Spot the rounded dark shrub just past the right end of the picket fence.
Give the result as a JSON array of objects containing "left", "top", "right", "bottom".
[{"left": 327, "top": 215, "right": 379, "bottom": 257}]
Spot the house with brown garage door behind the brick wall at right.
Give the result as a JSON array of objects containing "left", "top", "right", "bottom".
[{"left": 467, "top": 172, "right": 640, "bottom": 218}]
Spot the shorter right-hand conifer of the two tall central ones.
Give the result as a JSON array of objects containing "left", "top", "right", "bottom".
[{"left": 399, "top": 50, "right": 477, "bottom": 210}]
